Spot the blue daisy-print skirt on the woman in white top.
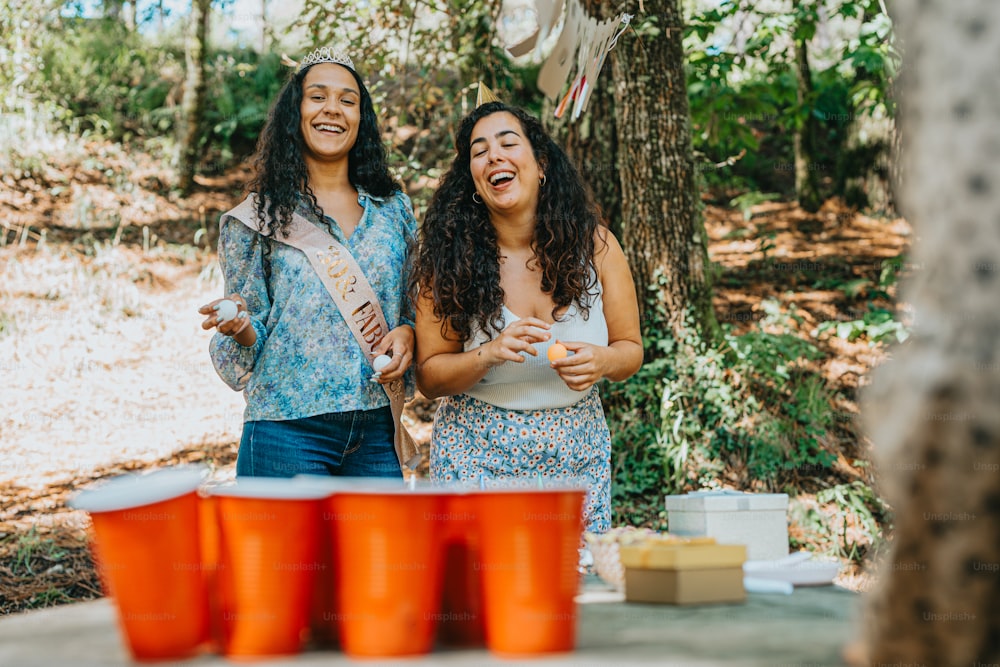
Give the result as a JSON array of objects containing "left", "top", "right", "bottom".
[{"left": 430, "top": 389, "right": 611, "bottom": 533}]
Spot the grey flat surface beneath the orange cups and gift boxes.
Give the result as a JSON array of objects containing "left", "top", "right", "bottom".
[{"left": 0, "top": 578, "right": 861, "bottom": 667}]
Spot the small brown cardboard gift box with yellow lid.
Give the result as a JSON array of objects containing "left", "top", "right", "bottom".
[{"left": 619, "top": 538, "right": 746, "bottom": 605}]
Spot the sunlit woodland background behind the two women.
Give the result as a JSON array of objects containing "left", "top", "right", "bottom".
[{"left": 0, "top": 0, "right": 908, "bottom": 612}]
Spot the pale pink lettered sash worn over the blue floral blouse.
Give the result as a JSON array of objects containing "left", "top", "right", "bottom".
[{"left": 225, "top": 194, "right": 421, "bottom": 470}]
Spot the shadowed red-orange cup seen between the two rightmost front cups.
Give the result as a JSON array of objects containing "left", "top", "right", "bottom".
[{"left": 438, "top": 490, "right": 486, "bottom": 646}]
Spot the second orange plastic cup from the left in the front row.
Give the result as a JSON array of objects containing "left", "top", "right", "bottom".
[{"left": 211, "top": 478, "right": 329, "bottom": 659}]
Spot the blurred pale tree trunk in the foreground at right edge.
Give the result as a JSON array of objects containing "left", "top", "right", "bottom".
[{"left": 864, "top": 0, "right": 1000, "bottom": 666}]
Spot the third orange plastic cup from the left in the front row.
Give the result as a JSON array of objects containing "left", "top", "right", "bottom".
[{"left": 327, "top": 487, "right": 444, "bottom": 657}]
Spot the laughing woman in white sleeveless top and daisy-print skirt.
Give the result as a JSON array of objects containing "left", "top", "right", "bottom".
[{"left": 411, "top": 102, "right": 642, "bottom": 532}]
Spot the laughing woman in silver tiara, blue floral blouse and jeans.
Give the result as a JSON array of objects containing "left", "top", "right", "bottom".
[{"left": 199, "top": 48, "right": 416, "bottom": 477}]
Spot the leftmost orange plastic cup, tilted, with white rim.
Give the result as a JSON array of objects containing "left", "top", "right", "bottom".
[{"left": 70, "top": 467, "right": 209, "bottom": 661}]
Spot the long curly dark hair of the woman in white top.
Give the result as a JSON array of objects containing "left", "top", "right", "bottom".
[{"left": 410, "top": 102, "right": 601, "bottom": 343}]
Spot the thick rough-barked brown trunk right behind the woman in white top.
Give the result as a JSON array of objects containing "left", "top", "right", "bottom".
[{"left": 611, "top": 0, "right": 718, "bottom": 340}]
